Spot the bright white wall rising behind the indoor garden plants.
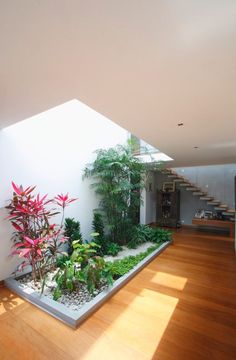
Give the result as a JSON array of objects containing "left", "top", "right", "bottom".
[{"left": 0, "top": 100, "right": 128, "bottom": 280}]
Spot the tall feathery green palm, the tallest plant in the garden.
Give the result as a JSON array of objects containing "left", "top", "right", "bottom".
[{"left": 84, "top": 145, "right": 146, "bottom": 245}]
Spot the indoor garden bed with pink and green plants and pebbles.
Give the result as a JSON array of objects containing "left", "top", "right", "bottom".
[{"left": 7, "top": 145, "right": 171, "bottom": 310}]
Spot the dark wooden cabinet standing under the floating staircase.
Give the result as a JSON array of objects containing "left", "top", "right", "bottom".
[{"left": 156, "top": 190, "right": 180, "bottom": 227}]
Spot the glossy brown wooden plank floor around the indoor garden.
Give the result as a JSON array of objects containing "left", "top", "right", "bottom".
[{"left": 0, "top": 230, "right": 236, "bottom": 360}]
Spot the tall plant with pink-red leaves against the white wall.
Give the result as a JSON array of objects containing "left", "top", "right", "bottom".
[{"left": 6, "top": 182, "right": 76, "bottom": 281}]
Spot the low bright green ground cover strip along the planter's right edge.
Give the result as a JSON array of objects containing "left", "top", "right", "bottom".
[{"left": 109, "top": 244, "right": 160, "bottom": 279}]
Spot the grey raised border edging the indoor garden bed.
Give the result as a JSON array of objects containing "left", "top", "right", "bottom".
[{"left": 5, "top": 241, "right": 173, "bottom": 329}]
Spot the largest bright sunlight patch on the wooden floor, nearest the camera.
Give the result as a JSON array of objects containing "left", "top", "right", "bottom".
[{"left": 83, "top": 289, "right": 179, "bottom": 359}]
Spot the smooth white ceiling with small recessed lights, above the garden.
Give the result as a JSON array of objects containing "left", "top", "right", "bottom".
[{"left": 0, "top": 0, "right": 236, "bottom": 166}]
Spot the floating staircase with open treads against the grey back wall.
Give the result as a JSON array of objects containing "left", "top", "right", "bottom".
[{"left": 162, "top": 169, "right": 235, "bottom": 221}]
